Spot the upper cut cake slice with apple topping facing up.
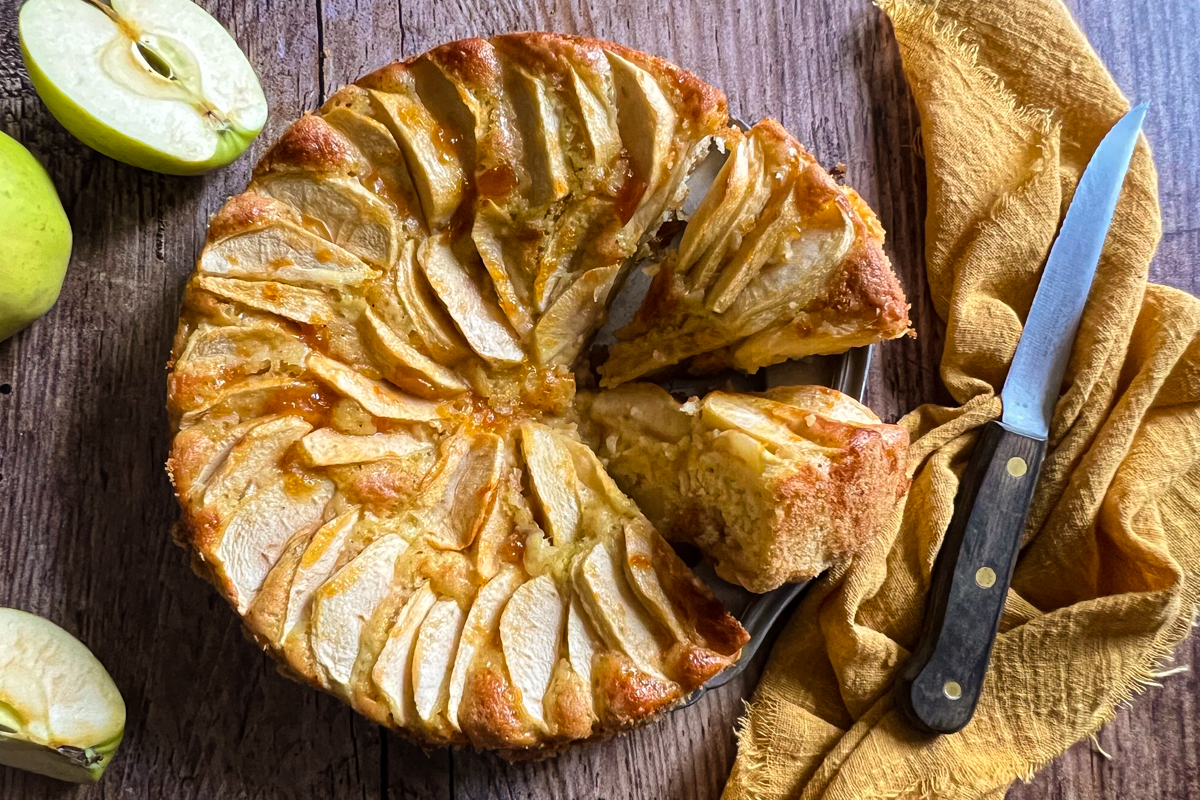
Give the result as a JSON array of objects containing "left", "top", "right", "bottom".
[{"left": 600, "top": 120, "right": 910, "bottom": 386}]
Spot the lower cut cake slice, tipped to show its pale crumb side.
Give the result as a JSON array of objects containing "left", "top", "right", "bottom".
[{"left": 581, "top": 383, "right": 908, "bottom": 593}]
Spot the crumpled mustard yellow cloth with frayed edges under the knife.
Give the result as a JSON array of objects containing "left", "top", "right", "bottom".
[{"left": 725, "top": 0, "right": 1200, "bottom": 800}]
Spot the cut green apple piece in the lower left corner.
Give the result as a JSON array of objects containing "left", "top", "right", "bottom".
[{"left": 0, "top": 608, "right": 125, "bottom": 783}]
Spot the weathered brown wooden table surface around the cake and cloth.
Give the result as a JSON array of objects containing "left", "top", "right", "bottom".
[{"left": 0, "top": 0, "right": 1200, "bottom": 800}]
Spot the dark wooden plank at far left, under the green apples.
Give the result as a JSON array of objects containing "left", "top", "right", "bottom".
[{"left": 0, "top": 0, "right": 380, "bottom": 800}]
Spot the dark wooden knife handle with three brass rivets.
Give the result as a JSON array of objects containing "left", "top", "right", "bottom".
[{"left": 896, "top": 422, "right": 1046, "bottom": 733}]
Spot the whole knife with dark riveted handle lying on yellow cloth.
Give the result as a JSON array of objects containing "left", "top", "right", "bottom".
[{"left": 896, "top": 103, "right": 1146, "bottom": 733}]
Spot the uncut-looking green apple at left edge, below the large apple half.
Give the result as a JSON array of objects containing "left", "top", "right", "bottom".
[{"left": 0, "top": 133, "right": 71, "bottom": 342}]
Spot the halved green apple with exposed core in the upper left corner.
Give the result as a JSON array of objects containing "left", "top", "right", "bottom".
[{"left": 20, "top": 0, "right": 266, "bottom": 175}]
